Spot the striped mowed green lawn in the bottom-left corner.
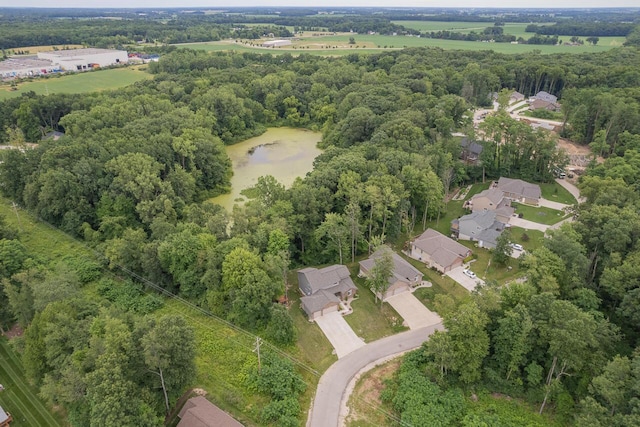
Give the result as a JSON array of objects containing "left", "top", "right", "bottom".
[{"left": 0, "top": 338, "right": 63, "bottom": 427}]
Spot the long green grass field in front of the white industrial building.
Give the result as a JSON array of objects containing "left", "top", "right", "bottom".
[{"left": 0, "top": 67, "right": 153, "bottom": 101}]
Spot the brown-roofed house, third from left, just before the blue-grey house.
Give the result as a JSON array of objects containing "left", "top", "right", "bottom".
[{"left": 410, "top": 228, "right": 471, "bottom": 273}]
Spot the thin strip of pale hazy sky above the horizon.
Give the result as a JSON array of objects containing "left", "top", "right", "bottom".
[{"left": 12, "top": 0, "right": 639, "bottom": 8}]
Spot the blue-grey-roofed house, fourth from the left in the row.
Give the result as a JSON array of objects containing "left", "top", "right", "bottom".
[{"left": 451, "top": 211, "right": 505, "bottom": 249}]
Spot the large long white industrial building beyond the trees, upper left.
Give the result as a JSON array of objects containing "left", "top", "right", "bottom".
[{"left": 38, "top": 48, "right": 129, "bottom": 71}]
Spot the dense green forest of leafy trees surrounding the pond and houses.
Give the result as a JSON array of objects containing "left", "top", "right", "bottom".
[{"left": 0, "top": 10, "right": 640, "bottom": 427}]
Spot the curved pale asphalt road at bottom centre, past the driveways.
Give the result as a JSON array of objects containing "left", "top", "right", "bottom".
[{"left": 307, "top": 323, "right": 444, "bottom": 427}]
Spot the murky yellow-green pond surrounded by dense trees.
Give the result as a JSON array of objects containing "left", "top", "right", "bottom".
[{"left": 211, "top": 128, "right": 322, "bottom": 212}]
